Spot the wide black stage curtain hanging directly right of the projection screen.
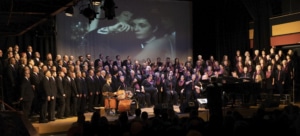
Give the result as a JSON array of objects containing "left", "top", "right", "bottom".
[{"left": 193, "top": 0, "right": 251, "bottom": 61}]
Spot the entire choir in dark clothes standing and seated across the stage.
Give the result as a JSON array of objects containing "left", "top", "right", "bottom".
[{"left": 0, "top": 45, "right": 294, "bottom": 123}]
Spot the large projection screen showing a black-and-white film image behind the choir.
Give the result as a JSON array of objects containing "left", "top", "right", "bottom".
[{"left": 56, "top": 0, "right": 192, "bottom": 61}]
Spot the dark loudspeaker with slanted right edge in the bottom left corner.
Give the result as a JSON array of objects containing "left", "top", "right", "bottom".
[{"left": 0, "top": 111, "right": 39, "bottom": 136}]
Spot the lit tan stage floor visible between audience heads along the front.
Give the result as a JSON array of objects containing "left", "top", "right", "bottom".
[{"left": 32, "top": 103, "right": 300, "bottom": 136}]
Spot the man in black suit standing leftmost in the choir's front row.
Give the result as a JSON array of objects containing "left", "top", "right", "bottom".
[{"left": 20, "top": 70, "right": 34, "bottom": 118}]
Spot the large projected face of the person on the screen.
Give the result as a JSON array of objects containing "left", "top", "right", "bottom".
[{"left": 132, "top": 18, "right": 153, "bottom": 39}]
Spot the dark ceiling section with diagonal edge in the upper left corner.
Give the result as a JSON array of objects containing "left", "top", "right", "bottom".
[{"left": 0, "top": 0, "right": 73, "bottom": 36}]
